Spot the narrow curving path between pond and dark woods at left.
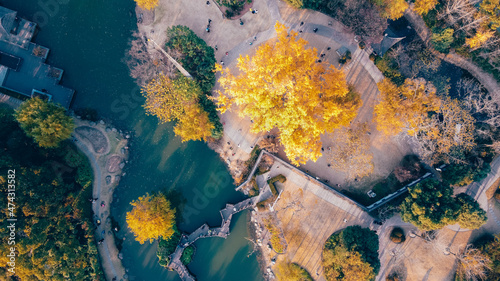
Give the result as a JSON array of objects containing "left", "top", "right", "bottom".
[{"left": 73, "top": 119, "right": 128, "bottom": 281}]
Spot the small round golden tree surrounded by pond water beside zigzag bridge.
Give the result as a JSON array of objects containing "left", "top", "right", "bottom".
[{"left": 126, "top": 193, "right": 175, "bottom": 244}]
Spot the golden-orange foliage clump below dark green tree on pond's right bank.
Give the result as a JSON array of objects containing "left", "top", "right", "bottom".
[{"left": 142, "top": 75, "right": 215, "bottom": 141}]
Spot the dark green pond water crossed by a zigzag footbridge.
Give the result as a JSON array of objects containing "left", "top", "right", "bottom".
[{"left": 0, "top": 0, "right": 262, "bottom": 281}]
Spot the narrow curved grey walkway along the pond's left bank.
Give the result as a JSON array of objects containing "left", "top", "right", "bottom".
[{"left": 72, "top": 119, "right": 128, "bottom": 281}]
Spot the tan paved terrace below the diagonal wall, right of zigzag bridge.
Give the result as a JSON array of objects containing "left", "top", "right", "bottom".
[{"left": 257, "top": 152, "right": 378, "bottom": 281}]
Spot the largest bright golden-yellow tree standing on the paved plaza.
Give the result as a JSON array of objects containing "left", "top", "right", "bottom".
[{"left": 216, "top": 23, "right": 361, "bottom": 165}]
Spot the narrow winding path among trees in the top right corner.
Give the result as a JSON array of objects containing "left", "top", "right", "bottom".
[{"left": 405, "top": 4, "right": 500, "bottom": 97}]
